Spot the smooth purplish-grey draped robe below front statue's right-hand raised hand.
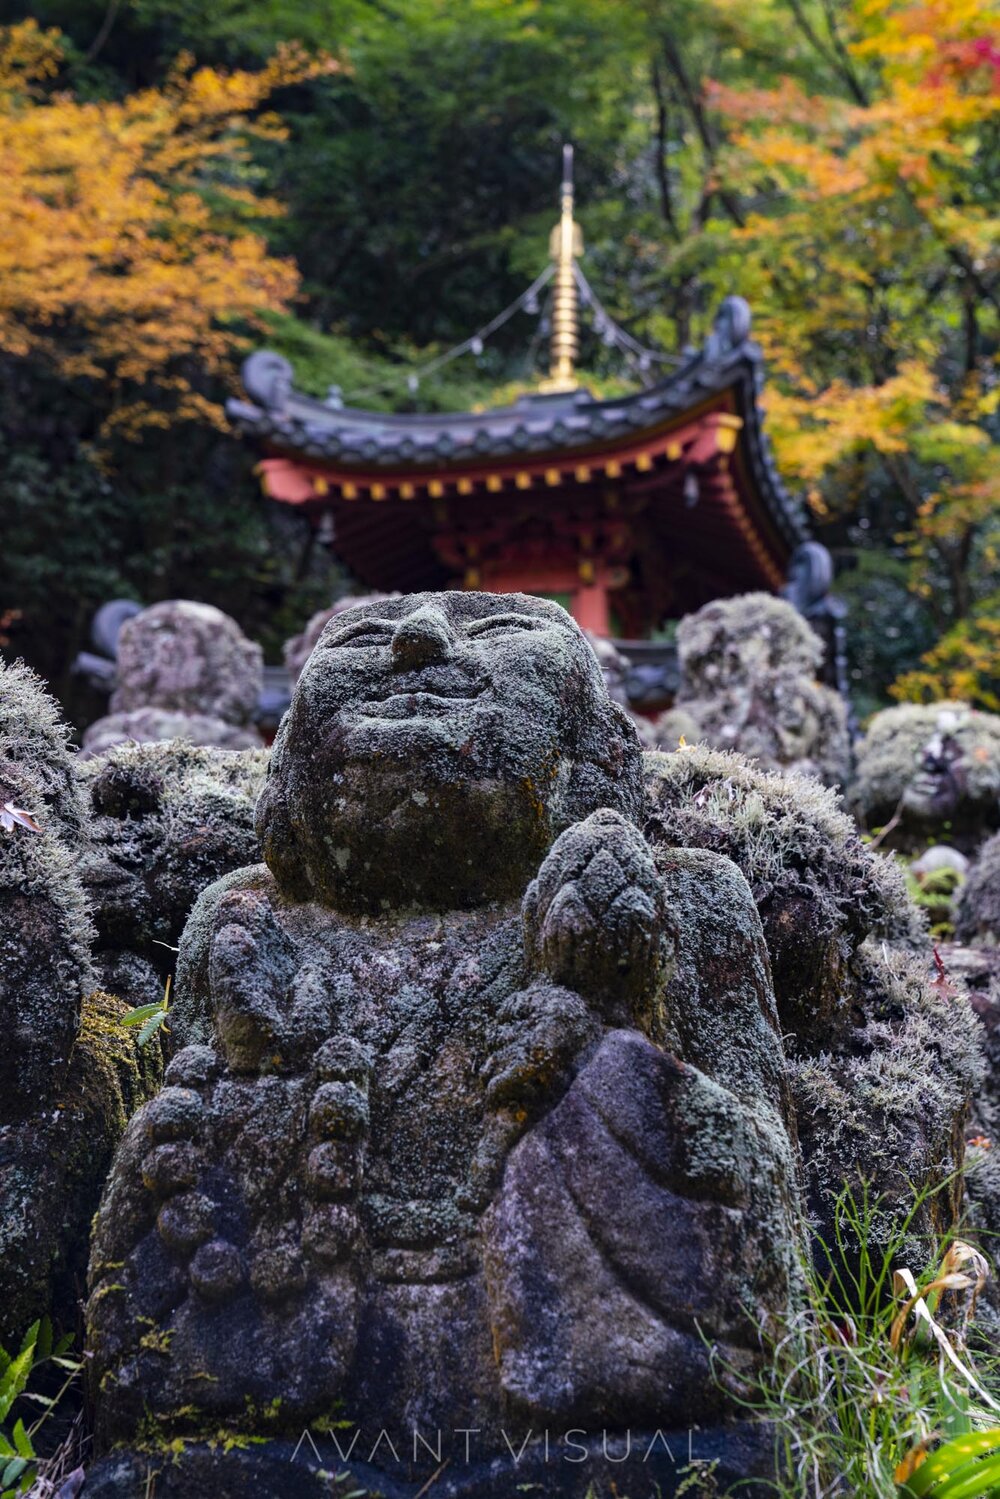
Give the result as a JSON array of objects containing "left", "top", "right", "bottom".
[{"left": 484, "top": 1030, "right": 792, "bottom": 1430}]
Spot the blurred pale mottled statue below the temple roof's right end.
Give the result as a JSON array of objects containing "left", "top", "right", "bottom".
[{"left": 655, "top": 594, "right": 850, "bottom": 785}]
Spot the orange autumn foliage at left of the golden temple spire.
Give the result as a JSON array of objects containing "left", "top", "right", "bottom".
[{"left": 0, "top": 21, "right": 333, "bottom": 438}]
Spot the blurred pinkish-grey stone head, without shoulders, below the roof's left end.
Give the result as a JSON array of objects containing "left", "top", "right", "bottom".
[{"left": 111, "top": 600, "right": 262, "bottom": 724}]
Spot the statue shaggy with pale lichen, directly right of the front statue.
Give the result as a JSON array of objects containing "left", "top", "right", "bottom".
[{"left": 646, "top": 747, "right": 981, "bottom": 1255}]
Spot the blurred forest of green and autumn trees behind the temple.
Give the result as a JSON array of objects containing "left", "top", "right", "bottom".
[{"left": 0, "top": 0, "right": 1000, "bottom": 712}]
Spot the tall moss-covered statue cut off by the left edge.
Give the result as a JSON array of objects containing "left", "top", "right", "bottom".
[{"left": 0, "top": 664, "right": 151, "bottom": 1346}]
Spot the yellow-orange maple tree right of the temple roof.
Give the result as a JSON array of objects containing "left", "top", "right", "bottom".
[{"left": 695, "top": 0, "right": 1000, "bottom": 696}]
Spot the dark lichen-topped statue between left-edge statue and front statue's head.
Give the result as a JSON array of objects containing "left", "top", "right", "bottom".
[{"left": 79, "top": 744, "right": 267, "bottom": 1004}]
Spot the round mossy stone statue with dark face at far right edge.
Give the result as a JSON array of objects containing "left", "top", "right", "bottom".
[{"left": 849, "top": 703, "right": 1000, "bottom": 853}]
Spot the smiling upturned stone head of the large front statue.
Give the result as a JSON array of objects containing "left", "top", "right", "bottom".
[{"left": 251, "top": 592, "right": 640, "bottom": 910}]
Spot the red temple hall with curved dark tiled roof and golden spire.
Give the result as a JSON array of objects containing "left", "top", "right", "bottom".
[{"left": 228, "top": 149, "right": 829, "bottom": 659}]
